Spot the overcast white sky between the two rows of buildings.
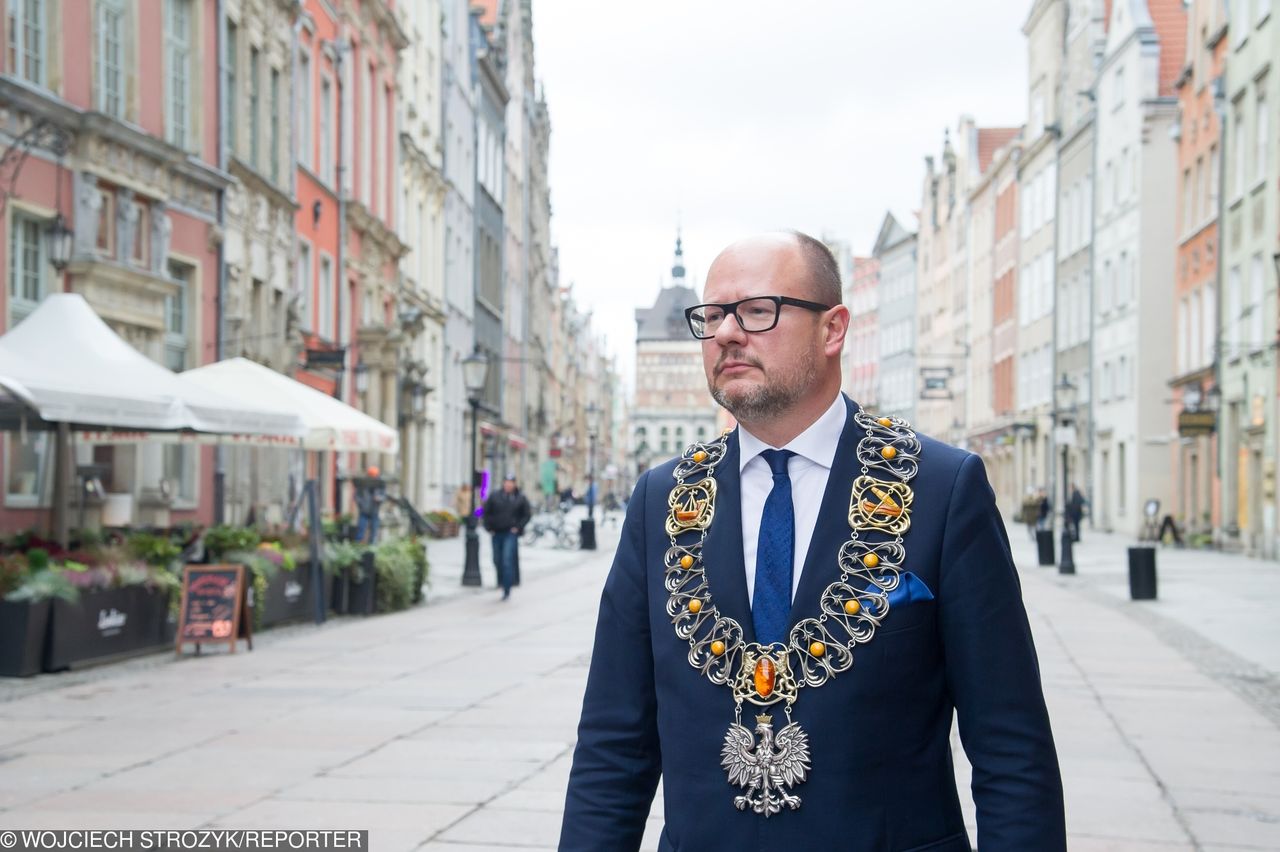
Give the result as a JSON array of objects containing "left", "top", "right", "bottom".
[{"left": 534, "top": 0, "right": 1032, "bottom": 378}]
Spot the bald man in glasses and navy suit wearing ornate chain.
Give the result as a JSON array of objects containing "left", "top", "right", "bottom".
[{"left": 559, "top": 233, "right": 1066, "bottom": 852}]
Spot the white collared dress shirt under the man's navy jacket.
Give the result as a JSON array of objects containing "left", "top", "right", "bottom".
[{"left": 737, "top": 394, "right": 849, "bottom": 601}]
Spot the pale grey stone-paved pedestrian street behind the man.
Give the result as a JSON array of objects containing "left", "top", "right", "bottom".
[{"left": 0, "top": 510, "right": 1280, "bottom": 852}]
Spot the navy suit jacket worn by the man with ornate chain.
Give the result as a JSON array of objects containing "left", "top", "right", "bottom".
[{"left": 559, "top": 399, "right": 1066, "bottom": 852}]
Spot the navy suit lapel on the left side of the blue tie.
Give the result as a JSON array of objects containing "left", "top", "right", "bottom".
[{"left": 703, "top": 429, "right": 755, "bottom": 642}]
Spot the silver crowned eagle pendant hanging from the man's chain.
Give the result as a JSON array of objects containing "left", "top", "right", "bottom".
[{"left": 721, "top": 715, "right": 809, "bottom": 817}]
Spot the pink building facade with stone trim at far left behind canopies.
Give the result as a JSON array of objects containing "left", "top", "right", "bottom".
[{"left": 0, "top": 0, "right": 228, "bottom": 530}]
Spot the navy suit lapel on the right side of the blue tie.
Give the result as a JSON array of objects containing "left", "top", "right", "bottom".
[{"left": 783, "top": 397, "right": 863, "bottom": 627}]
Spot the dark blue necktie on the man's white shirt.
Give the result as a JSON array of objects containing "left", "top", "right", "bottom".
[{"left": 751, "top": 450, "right": 796, "bottom": 645}]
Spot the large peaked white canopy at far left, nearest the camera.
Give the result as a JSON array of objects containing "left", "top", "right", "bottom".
[{"left": 0, "top": 293, "right": 303, "bottom": 443}]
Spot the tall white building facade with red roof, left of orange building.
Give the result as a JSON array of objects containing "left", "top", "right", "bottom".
[{"left": 1092, "top": 0, "right": 1185, "bottom": 536}]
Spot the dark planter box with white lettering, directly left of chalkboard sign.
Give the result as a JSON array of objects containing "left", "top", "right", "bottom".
[{"left": 45, "top": 586, "right": 170, "bottom": 672}]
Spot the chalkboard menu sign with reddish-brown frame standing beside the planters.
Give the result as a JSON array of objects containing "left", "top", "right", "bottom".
[{"left": 175, "top": 565, "right": 253, "bottom": 656}]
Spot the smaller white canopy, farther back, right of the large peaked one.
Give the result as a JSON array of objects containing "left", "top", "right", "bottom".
[{"left": 180, "top": 358, "right": 399, "bottom": 454}]
